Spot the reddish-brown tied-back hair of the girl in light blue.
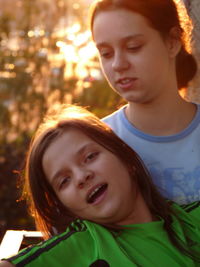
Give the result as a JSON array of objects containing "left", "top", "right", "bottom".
[{"left": 90, "top": 0, "right": 197, "bottom": 89}]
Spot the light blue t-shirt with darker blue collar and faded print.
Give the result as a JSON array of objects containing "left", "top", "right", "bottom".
[{"left": 103, "top": 106, "right": 200, "bottom": 204}]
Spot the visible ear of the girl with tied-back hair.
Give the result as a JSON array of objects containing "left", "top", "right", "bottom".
[{"left": 167, "top": 27, "right": 182, "bottom": 58}]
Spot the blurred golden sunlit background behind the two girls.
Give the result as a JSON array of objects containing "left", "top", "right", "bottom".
[{"left": 0, "top": 0, "right": 200, "bottom": 242}]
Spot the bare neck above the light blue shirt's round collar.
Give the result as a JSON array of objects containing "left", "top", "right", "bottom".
[{"left": 125, "top": 94, "right": 196, "bottom": 136}]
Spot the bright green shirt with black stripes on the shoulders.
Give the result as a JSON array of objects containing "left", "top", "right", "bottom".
[{"left": 6, "top": 203, "right": 200, "bottom": 267}]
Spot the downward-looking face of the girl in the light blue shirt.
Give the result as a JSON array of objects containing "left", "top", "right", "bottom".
[{"left": 93, "top": 9, "right": 180, "bottom": 103}]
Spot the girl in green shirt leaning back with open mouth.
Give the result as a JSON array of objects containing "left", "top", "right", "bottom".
[{"left": 0, "top": 106, "right": 200, "bottom": 267}]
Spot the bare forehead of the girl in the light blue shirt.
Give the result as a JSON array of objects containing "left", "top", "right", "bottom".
[{"left": 92, "top": 9, "right": 152, "bottom": 44}]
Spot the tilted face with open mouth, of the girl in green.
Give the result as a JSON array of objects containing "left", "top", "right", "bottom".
[{"left": 43, "top": 129, "right": 140, "bottom": 224}]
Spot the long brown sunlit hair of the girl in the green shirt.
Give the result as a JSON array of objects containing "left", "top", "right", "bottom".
[{"left": 24, "top": 105, "right": 199, "bottom": 262}]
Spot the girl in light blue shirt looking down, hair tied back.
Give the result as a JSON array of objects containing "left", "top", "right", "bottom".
[{"left": 90, "top": 0, "right": 200, "bottom": 204}]
